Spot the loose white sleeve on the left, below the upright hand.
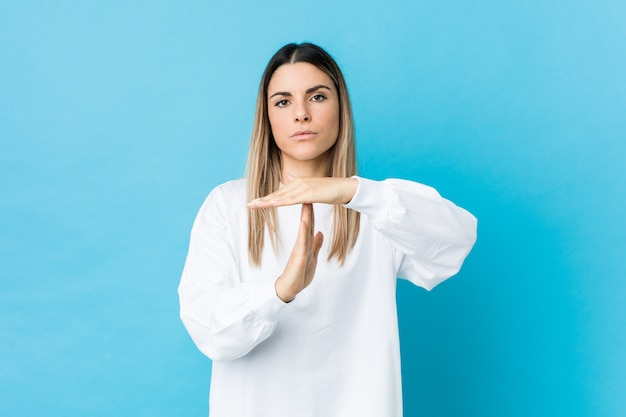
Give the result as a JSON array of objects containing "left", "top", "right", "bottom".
[{"left": 178, "top": 185, "right": 284, "bottom": 361}]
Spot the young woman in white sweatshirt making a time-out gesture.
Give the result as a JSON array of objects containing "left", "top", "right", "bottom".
[{"left": 179, "top": 43, "right": 476, "bottom": 417}]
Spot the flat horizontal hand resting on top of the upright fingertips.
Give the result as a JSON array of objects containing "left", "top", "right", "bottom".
[{"left": 248, "top": 177, "right": 359, "bottom": 209}]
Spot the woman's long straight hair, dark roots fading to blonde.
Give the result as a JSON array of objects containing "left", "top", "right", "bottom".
[{"left": 247, "top": 43, "right": 360, "bottom": 266}]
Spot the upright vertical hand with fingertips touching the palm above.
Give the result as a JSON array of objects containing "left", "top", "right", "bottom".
[{"left": 274, "top": 204, "right": 324, "bottom": 303}]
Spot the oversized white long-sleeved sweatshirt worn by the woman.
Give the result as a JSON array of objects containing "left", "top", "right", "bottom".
[{"left": 179, "top": 178, "right": 477, "bottom": 417}]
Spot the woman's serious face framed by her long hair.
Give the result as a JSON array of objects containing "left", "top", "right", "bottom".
[{"left": 267, "top": 62, "right": 339, "bottom": 174}]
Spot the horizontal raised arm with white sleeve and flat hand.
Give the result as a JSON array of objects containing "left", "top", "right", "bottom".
[{"left": 248, "top": 177, "right": 477, "bottom": 290}]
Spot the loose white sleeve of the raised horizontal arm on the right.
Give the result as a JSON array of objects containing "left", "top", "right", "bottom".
[{"left": 345, "top": 177, "right": 477, "bottom": 290}]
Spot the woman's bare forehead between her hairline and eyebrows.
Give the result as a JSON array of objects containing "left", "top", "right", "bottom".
[{"left": 267, "top": 62, "right": 334, "bottom": 95}]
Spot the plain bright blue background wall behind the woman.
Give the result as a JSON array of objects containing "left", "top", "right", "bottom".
[{"left": 0, "top": 0, "right": 626, "bottom": 417}]
